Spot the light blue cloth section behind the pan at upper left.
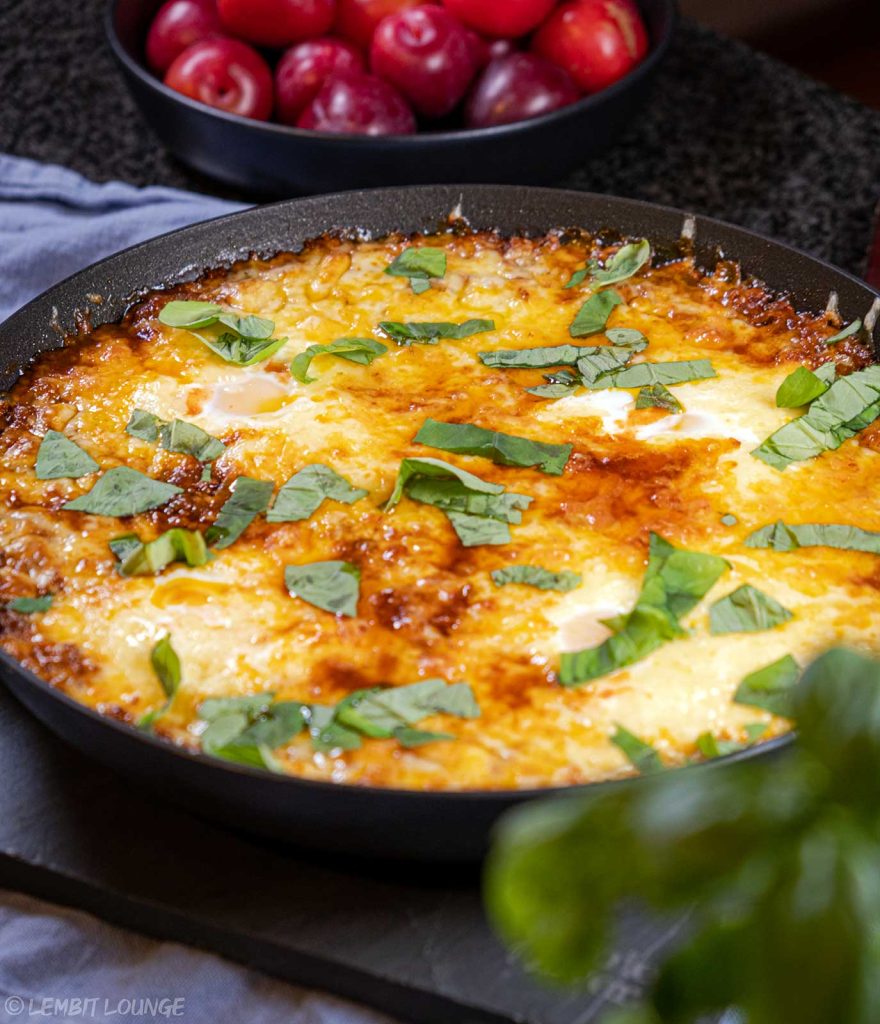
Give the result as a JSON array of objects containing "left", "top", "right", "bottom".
[{"left": 0, "top": 154, "right": 242, "bottom": 322}]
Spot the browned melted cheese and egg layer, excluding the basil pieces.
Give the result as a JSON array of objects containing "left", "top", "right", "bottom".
[{"left": 0, "top": 234, "right": 880, "bottom": 788}]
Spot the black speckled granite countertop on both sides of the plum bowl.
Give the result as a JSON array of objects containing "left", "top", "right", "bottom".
[{"left": 0, "top": 0, "right": 880, "bottom": 272}]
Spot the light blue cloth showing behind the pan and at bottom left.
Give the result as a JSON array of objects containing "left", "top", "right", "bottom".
[{"left": 0, "top": 154, "right": 391, "bottom": 1024}]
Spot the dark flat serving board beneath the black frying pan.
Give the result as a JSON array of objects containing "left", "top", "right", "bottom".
[{"left": 0, "top": 688, "right": 696, "bottom": 1024}]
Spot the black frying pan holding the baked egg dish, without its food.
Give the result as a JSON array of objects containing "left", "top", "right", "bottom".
[{"left": 0, "top": 185, "right": 880, "bottom": 861}]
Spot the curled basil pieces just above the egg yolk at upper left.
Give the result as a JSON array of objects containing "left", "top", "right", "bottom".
[{"left": 159, "top": 300, "right": 287, "bottom": 367}]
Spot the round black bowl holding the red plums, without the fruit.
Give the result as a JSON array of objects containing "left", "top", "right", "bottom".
[{"left": 107, "top": 0, "right": 676, "bottom": 196}]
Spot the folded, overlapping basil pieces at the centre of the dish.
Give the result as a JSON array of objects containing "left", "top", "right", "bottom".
[{"left": 385, "top": 459, "right": 532, "bottom": 548}]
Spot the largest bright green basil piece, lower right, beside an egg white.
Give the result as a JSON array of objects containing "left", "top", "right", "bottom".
[{"left": 559, "top": 534, "right": 729, "bottom": 686}]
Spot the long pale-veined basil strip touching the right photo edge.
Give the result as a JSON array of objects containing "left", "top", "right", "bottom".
[{"left": 752, "top": 366, "right": 880, "bottom": 470}]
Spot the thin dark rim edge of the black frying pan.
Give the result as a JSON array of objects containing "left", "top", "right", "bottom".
[{"left": 0, "top": 184, "right": 880, "bottom": 804}]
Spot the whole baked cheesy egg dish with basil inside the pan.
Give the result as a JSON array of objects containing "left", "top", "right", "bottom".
[{"left": 0, "top": 227, "right": 880, "bottom": 790}]
